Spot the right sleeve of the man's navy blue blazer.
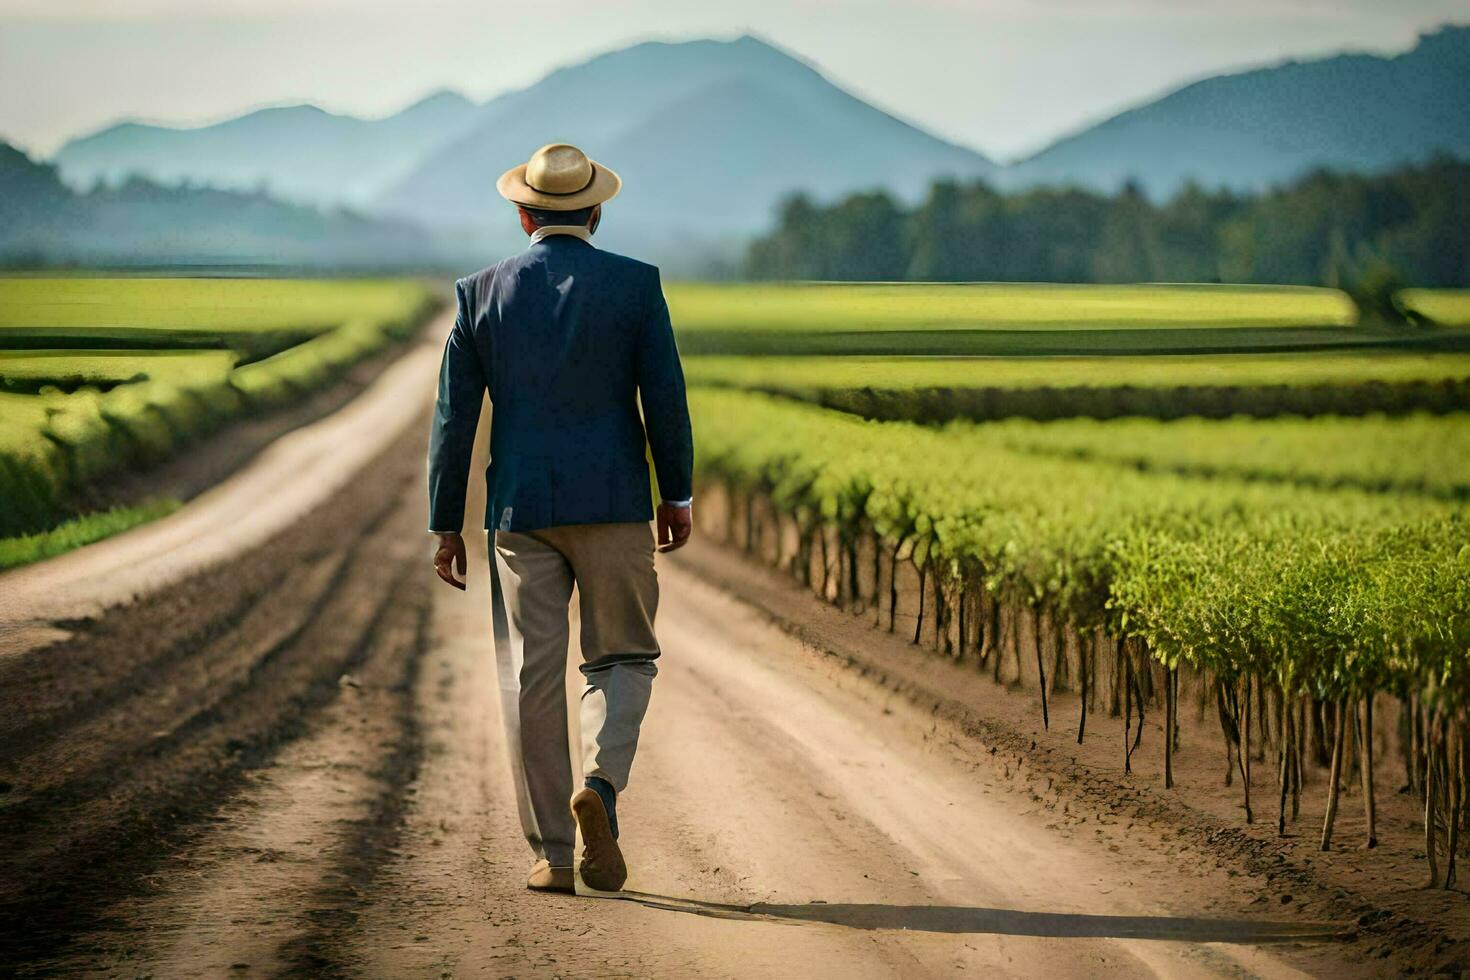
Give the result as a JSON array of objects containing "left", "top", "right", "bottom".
[{"left": 638, "top": 269, "right": 694, "bottom": 501}]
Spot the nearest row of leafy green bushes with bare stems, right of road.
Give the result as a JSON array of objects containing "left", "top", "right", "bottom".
[{"left": 691, "top": 391, "right": 1470, "bottom": 884}]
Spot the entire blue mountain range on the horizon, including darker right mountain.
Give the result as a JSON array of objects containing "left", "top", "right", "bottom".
[{"left": 31, "top": 25, "right": 1470, "bottom": 268}]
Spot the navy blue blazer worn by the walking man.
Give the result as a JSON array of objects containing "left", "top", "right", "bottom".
[{"left": 429, "top": 235, "right": 694, "bottom": 532}]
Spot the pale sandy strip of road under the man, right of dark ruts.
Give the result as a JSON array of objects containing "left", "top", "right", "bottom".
[{"left": 340, "top": 542, "right": 1334, "bottom": 979}]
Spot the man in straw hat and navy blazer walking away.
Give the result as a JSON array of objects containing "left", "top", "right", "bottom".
[{"left": 429, "top": 143, "right": 694, "bottom": 893}]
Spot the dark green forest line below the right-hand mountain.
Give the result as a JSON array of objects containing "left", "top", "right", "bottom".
[{"left": 744, "top": 157, "right": 1470, "bottom": 287}]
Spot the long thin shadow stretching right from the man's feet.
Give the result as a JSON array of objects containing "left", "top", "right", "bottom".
[{"left": 594, "top": 892, "right": 1352, "bottom": 943}]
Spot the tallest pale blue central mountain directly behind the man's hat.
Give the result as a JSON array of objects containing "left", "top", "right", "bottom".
[{"left": 375, "top": 37, "right": 995, "bottom": 251}]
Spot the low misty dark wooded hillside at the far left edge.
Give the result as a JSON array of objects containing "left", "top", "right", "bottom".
[{"left": 0, "top": 143, "right": 437, "bottom": 267}]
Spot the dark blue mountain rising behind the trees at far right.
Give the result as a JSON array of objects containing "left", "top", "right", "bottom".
[{"left": 1003, "top": 26, "right": 1470, "bottom": 197}]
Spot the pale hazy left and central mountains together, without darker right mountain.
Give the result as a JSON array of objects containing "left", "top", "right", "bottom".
[{"left": 56, "top": 34, "right": 997, "bottom": 258}]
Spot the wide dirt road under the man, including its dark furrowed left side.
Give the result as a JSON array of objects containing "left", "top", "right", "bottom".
[{"left": 0, "top": 333, "right": 1336, "bottom": 977}]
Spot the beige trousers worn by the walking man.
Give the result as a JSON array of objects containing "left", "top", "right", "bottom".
[{"left": 491, "top": 523, "right": 659, "bottom": 867}]
